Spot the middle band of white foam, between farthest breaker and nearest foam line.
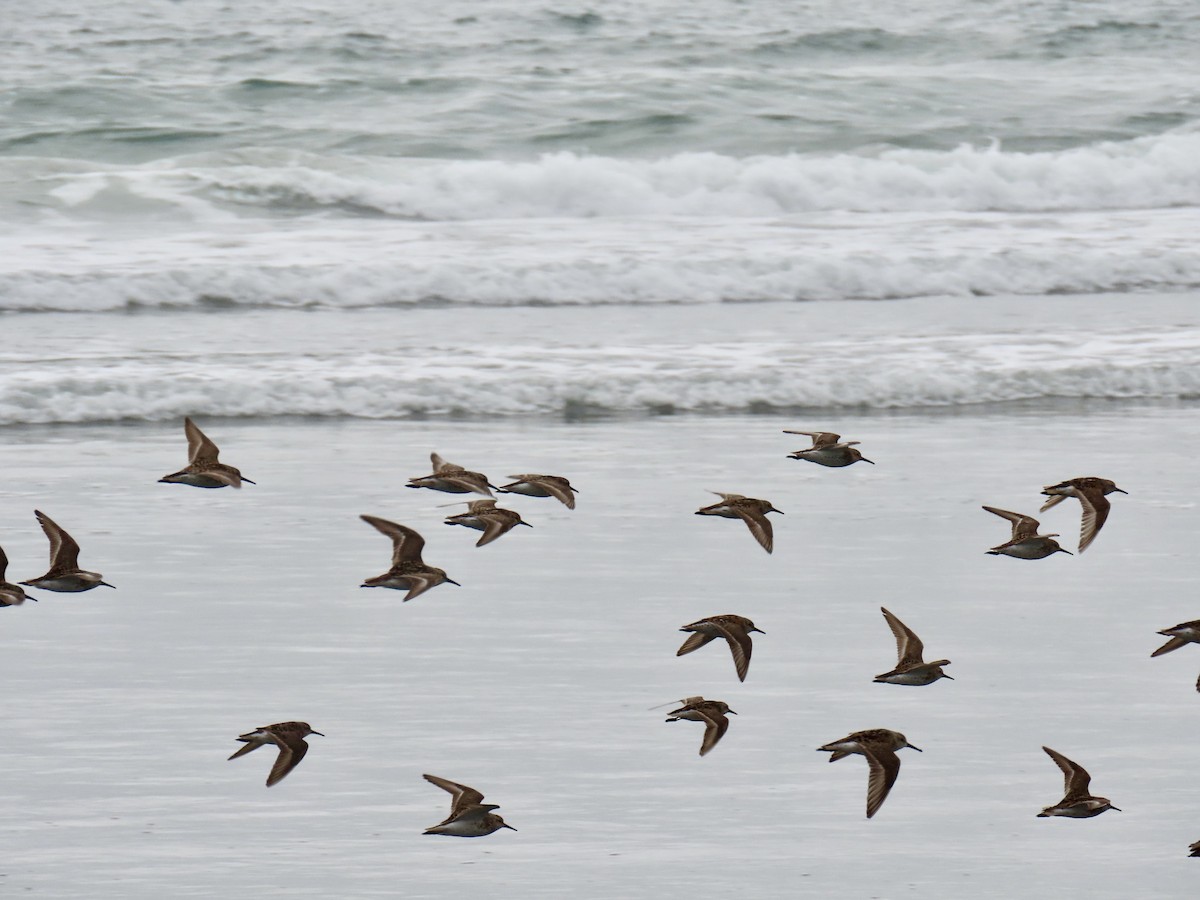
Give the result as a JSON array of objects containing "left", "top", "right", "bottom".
[{"left": 0, "top": 209, "right": 1200, "bottom": 312}]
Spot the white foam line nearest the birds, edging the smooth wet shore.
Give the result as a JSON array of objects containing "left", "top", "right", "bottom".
[{"left": 0, "top": 329, "right": 1200, "bottom": 424}]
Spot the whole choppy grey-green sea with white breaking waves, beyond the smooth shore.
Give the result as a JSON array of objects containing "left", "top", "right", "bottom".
[{"left": 7, "top": 0, "right": 1200, "bottom": 424}]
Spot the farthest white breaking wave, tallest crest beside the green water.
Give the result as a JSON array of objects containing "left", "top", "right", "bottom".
[{"left": 4, "top": 131, "right": 1200, "bottom": 221}]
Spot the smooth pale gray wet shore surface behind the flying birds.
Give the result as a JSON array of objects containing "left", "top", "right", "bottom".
[{"left": 0, "top": 402, "right": 1200, "bottom": 898}]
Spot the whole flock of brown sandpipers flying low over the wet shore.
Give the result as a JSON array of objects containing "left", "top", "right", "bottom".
[{"left": 7, "top": 419, "right": 1200, "bottom": 857}]
